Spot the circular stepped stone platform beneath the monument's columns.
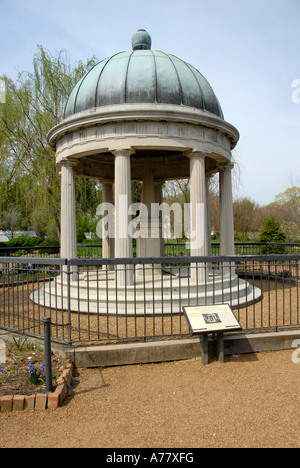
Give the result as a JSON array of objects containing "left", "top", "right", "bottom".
[{"left": 31, "top": 269, "right": 261, "bottom": 316}]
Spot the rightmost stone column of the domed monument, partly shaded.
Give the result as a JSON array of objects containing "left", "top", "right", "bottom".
[{"left": 220, "top": 164, "right": 234, "bottom": 274}]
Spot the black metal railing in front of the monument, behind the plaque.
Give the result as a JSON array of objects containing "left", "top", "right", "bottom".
[{"left": 0, "top": 255, "right": 300, "bottom": 344}]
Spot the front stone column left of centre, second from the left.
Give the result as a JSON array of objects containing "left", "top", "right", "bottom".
[{"left": 112, "top": 149, "right": 133, "bottom": 286}]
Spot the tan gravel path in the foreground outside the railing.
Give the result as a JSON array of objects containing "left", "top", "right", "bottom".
[{"left": 0, "top": 350, "right": 300, "bottom": 448}]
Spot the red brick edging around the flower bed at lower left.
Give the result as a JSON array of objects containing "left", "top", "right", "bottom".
[{"left": 0, "top": 361, "right": 73, "bottom": 413}]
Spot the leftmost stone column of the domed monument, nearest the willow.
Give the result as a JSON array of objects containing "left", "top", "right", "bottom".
[{"left": 60, "top": 160, "right": 77, "bottom": 280}]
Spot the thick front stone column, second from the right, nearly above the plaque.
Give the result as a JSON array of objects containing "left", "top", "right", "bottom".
[{"left": 188, "top": 152, "right": 208, "bottom": 284}]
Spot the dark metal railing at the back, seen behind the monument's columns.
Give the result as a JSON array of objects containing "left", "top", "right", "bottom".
[{"left": 0, "top": 242, "right": 300, "bottom": 258}]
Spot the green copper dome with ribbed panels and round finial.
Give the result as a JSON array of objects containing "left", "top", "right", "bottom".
[{"left": 65, "top": 30, "right": 224, "bottom": 119}]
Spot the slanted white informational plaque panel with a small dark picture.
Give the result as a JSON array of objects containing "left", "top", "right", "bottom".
[{"left": 183, "top": 304, "right": 242, "bottom": 334}]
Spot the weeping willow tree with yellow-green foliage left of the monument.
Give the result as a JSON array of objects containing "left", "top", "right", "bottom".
[{"left": 0, "top": 46, "right": 97, "bottom": 238}]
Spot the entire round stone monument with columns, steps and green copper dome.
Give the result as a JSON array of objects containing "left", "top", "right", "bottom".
[{"left": 34, "top": 29, "right": 258, "bottom": 314}]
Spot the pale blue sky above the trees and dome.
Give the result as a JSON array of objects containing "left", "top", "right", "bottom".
[{"left": 0, "top": 0, "right": 300, "bottom": 205}]
